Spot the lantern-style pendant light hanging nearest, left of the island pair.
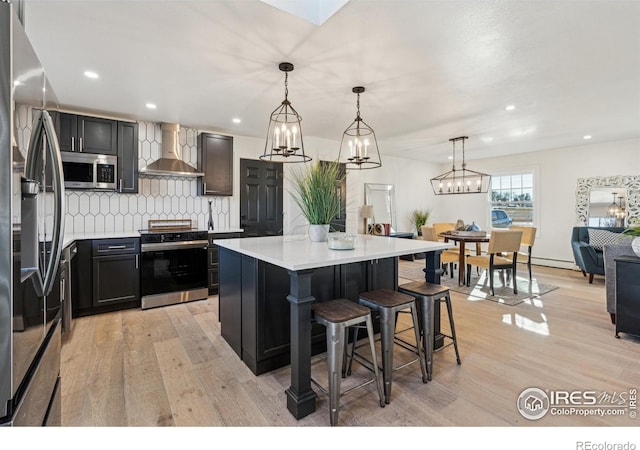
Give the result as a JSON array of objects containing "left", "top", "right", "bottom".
[{"left": 260, "top": 62, "right": 311, "bottom": 163}]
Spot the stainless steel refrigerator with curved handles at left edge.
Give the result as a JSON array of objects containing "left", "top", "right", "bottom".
[{"left": 0, "top": 0, "right": 65, "bottom": 426}]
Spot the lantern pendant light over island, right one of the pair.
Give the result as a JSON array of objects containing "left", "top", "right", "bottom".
[{"left": 338, "top": 86, "right": 382, "bottom": 170}]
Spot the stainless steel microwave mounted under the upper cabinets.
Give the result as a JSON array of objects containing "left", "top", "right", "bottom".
[{"left": 61, "top": 152, "right": 118, "bottom": 190}]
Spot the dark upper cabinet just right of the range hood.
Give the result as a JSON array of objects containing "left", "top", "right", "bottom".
[{"left": 198, "top": 133, "right": 233, "bottom": 196}]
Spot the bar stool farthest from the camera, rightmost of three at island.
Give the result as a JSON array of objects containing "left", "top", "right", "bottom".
[{"left": 398, "top": 281, "right": 461, "bottom": 381}]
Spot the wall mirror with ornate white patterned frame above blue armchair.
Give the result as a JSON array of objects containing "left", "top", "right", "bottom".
[{"left": 576, "top": 175, "right": 640, "bottom": 227}]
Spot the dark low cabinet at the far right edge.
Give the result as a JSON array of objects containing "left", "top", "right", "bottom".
[{"left": 615, "top": 256, "right": 640, "bottom": 337}]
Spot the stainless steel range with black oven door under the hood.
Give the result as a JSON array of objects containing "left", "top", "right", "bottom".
[{"left": 140, "top": 220, "right": 209, "bottom": 309}]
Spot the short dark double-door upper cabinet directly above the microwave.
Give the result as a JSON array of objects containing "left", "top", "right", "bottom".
[{"left": 56, "top": 113, "right": 118, "bottom": 156}]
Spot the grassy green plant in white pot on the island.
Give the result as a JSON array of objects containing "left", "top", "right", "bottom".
[{"left": 291, "top": 161, "right": 344, "bottom": 242}]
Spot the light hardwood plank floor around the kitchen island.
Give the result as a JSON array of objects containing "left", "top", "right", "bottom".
[{"left": 61, "top": 261, "right": 640, "bottom": 427}]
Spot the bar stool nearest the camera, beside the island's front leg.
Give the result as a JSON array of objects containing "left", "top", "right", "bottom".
[{"left": 311, "top": 298, "right": 385, "bottom": 426}]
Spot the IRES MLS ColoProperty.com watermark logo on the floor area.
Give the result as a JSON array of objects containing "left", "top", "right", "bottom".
[{"left": 517, "top": 387, "right": 638, "bottom": 420}]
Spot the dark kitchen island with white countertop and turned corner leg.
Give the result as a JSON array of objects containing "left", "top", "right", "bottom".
[{"left": 214, "top": 235, "right": 452, "bottom": 419}]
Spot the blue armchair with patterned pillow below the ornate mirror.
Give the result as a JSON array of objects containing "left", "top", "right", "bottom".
[{"left": 571, "top": 227, "right": 625, "bottom": 283}]
